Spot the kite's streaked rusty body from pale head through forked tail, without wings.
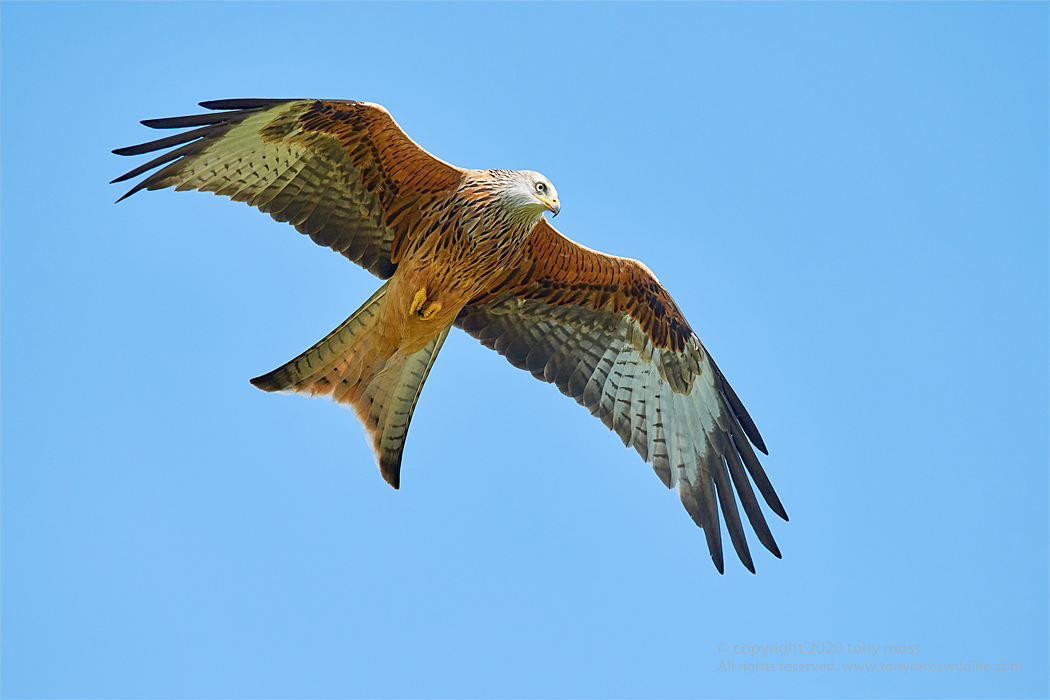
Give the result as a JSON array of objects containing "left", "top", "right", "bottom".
[{"left": 252, "top": 170, "right": 557, "bottom": 488}]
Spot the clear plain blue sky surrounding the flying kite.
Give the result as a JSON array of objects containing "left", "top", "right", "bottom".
[{"left": 0, "top": 2, "right": 1050, "bottom": 698}]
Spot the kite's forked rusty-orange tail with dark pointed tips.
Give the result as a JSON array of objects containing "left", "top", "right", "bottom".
[{"left": 251, "top": 283, "right": 452, "bottom": 488}]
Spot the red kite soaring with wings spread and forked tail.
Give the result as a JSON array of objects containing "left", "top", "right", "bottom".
[{"left": 113, "top": 100, "right": 788, "bottom": 573}]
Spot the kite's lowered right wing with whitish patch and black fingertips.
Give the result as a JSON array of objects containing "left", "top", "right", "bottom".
[{"left": 456, "top": 219, "right": 788, "bottom": 572}]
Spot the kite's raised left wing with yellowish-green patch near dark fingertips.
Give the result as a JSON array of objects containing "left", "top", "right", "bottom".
[{"left": 113, "top": 100, "right": 464, "bottom": 278}]
